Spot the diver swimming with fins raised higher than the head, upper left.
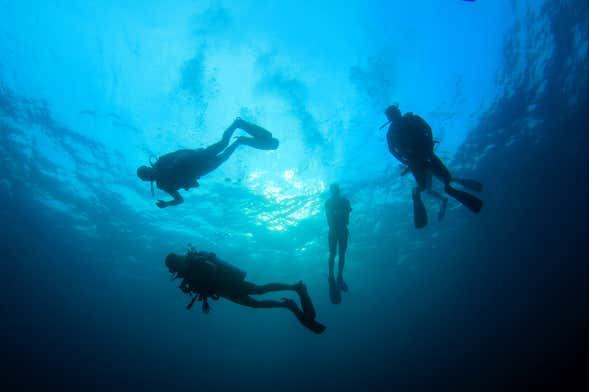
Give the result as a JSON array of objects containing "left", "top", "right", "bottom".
[{"left": 137, "top": 117, "right": 278, "bottom": 208}]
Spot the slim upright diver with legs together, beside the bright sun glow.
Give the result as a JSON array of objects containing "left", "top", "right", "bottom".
[{"left": 325, "top": 184, "right": 352, "bottom": 304}]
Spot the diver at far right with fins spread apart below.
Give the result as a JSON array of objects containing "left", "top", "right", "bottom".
[{"left": 381, "top": 105, "right": 483, "bottom": 228}]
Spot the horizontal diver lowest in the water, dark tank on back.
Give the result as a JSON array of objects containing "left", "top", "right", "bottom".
[{"left": 166, "top": 249, "right": 325, "bottom": 334}]
